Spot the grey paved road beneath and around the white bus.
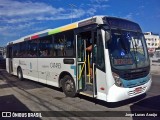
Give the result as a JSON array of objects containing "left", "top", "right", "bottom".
[{"left": 0, "top": 69, "right": 160, "bottom": 120}]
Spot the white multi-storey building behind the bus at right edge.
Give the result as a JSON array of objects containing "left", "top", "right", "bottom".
[{"left": 144, "top": 32, "right": 160, "bottom": 53}]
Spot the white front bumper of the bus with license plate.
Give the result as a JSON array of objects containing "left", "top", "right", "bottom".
[{"left": 107, "top": 79, "right": 152, "bottom": 102}]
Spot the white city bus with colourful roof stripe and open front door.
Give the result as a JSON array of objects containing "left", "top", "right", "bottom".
[{"left": 6, "top": 16, "right": 152, "bottom": 102}]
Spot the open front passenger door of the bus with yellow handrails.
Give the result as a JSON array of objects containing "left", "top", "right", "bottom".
[{"left": 77, "top": 29, "right": 97, "bottom": 97}]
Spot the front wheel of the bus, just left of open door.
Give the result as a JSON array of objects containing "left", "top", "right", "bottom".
[{"left": 61, "top": 75, "right": 76, "bottom": 97}]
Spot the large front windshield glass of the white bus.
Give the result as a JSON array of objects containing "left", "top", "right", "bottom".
[{"left": 106, "top": 29, "right": 149, "bottom": 69}]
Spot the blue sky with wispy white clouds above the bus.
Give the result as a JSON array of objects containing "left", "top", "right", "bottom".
[{"left": 0, "top": 0, "right": 160, "bottom": 46}]
